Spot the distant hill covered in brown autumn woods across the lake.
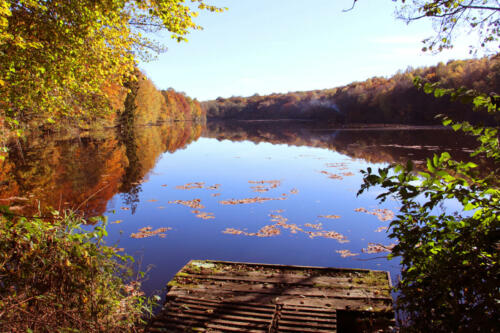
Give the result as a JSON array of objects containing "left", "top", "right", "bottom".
[{"left": 201, "top": 57, "right": 500, "bottom": 125}]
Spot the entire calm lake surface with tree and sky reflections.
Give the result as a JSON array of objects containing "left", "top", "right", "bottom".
[{"left": 0, "top": 123, "right": 472, "bottom": 293}]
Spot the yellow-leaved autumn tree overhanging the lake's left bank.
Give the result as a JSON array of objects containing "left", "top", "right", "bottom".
[{"left": 0, "top": 0, "right": 223, "bottom": 129}]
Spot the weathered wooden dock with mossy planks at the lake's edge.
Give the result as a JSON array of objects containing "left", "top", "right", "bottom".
[{"left": 149, "top": 260, "right": 394, "bottom": 332}]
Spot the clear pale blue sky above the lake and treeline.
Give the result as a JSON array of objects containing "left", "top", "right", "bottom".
[{"left": 140, "top": 0, "right": 471, "bottom": 101}]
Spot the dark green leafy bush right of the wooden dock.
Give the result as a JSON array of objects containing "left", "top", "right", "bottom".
[{"left": 359, "top": 72, "right": 500, "bottom": 331}]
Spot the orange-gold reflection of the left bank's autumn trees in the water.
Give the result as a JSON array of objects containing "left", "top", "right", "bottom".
[{"left": 0, "top": 122, "right": 202, "bottom": 215}]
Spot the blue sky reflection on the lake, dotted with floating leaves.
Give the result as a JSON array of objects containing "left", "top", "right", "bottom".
[{"left": 104, "top": 138, "right": 399, "bottom": 291}]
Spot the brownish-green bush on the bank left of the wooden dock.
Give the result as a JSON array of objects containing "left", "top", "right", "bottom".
[{"left": 0, "top": 207, "right": 152, "bottom": 332}]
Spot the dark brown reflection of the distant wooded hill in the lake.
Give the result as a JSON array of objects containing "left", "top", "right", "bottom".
[{"left": 203, "top": 121, "right": 476, "bottom": 165}]
